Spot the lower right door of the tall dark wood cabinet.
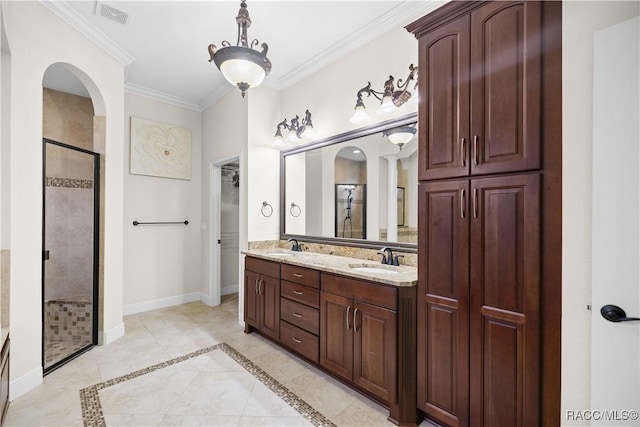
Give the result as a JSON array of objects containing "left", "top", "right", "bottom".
[{"left": 470, "top": 174, "right": 540, "bottom": 426}]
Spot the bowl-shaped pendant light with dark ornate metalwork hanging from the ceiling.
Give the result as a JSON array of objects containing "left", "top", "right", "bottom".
[{"left": 209, "top": 0, "right": 271, "bottom": 98}]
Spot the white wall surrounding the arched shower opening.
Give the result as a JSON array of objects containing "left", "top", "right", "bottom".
[{"left": 0, "top": 2, "right": 124, "bottom": 399}]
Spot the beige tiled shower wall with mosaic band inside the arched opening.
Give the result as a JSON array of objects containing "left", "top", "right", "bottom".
[{"left": 43, "top": 88, "right": 95, "bottom": 301}]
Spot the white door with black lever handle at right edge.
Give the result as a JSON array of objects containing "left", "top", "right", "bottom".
[{"left": 592, "top": 18, "right": 640, "bottom": 426}]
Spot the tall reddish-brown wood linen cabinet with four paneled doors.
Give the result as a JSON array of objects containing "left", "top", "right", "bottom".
[{"left": 407, "top": 1, "right": 562, "bottom": 426}]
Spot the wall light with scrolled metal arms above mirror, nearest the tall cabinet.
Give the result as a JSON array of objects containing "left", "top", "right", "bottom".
[{"left": 351, "top": 64, "right": 418, "bottom": 123}]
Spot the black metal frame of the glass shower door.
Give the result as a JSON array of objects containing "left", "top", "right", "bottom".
[{"left": 41, "top": 138, "right": 100, "bottom": 375}]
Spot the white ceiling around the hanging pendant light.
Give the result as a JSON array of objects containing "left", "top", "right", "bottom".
[{"left": 42, "top": 0, "right": 444, "bottom": 110}]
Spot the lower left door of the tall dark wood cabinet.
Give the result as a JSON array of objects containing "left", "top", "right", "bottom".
[{"left": 418, "top": 180, "right": 472, "bottom": 425}]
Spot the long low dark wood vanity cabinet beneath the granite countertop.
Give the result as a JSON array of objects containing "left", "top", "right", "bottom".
[{"left": 245, "top": 256, "right": 419, "bottom": 425}]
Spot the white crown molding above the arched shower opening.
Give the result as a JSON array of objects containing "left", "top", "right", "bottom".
[{"left": 39, "top": 0, "right": 135, "bottom": 67}]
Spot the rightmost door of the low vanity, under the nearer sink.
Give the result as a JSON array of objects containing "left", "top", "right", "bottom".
[{"left": 353, "top": 302, "right": 397, "bottom": 402}]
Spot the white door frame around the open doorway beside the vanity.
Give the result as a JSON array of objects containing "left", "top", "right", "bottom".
[{"left": 207, "top": 153, "right": 246, "bottom": 308}]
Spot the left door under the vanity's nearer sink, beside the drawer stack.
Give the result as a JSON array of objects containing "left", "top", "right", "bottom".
[{"left": 320, "top": 292, "right": 354, "bottom": 381}]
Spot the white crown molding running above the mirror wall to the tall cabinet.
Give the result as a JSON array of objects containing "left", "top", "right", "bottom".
[{"left": 272, "top": 0, "right": 449, "bottom": 90}]
